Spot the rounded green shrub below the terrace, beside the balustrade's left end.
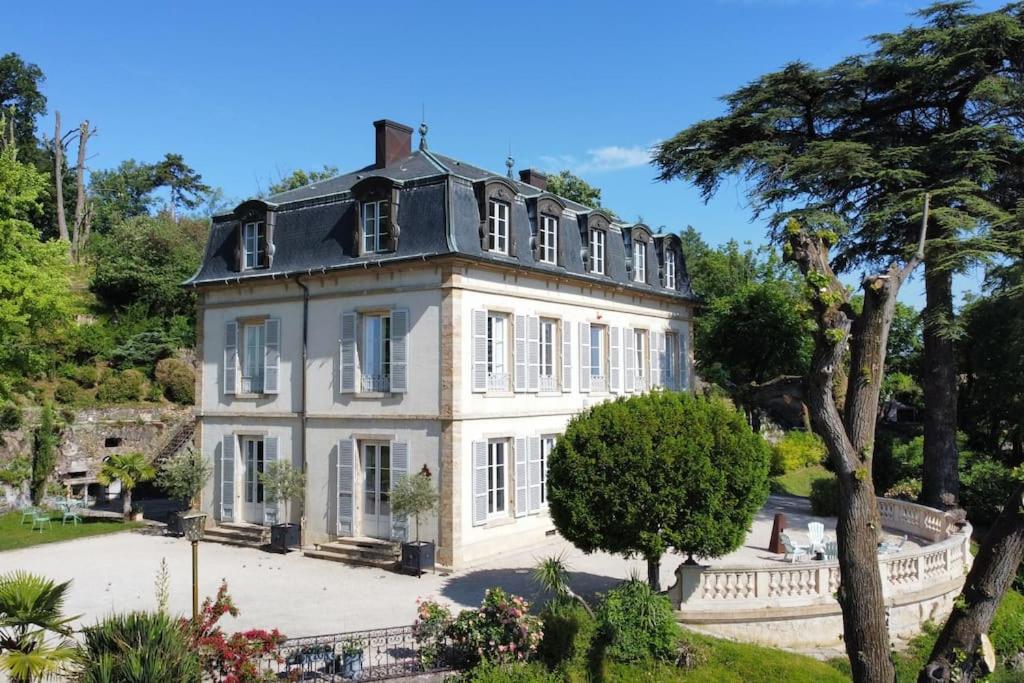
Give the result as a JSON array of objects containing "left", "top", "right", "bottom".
[{"left": 597, "top": 580, "right": 679, "bottom": 661}]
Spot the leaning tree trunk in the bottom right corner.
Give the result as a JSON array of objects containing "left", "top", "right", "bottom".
[{"left": 918, "top": 484, "right": 1024, "bottom": 683}]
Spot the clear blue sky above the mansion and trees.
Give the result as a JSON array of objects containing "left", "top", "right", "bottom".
[{"left": 6, "top": 0, "right": 1000, "bottom": 304}]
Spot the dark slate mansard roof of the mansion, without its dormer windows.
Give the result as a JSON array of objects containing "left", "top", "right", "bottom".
[{"left": 185, "top": 151, "right": 696, "bottom": 300}]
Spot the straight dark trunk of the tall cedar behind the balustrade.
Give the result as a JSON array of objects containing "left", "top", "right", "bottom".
[{"left": 921, "top": 263, "right": 959, "bottom": 510}]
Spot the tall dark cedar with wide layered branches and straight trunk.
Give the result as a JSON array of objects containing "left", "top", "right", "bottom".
[{"left": 655, "top": 2, "right": 1024, "bottom": 506}]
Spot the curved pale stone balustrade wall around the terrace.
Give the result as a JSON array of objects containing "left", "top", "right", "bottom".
[{"left": 669, "top": 498, "right": 972, "bottom": 648}]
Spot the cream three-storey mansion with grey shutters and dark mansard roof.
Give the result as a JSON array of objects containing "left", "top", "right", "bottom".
[{"left": 187, "top": 121, "right": 695, "bottom": 566}]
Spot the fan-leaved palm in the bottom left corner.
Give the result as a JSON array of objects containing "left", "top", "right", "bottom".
[{"left": 0, "top": 571, "right": 76, "bottom": 683}]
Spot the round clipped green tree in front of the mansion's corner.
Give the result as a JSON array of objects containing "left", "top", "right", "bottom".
[{"left": 548, "top": 392, "right": 770, "bottom": 590}]
